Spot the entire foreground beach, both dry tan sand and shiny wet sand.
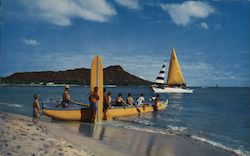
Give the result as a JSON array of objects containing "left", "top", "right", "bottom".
[{"left": 0, "top": 113, "right": 234, "bottom": 156}]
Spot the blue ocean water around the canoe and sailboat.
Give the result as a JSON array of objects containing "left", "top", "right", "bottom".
[{"left": 0, "top": 86, "right": 250, "bottom": 155}]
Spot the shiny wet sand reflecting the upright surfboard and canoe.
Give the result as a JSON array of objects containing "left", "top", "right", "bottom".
[{"left": 74, "top": 122, "right": 230, "bottom": 156}]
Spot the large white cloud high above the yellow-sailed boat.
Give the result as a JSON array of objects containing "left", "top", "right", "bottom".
[{"left": 161, "top": 1, "right": 215, "bottom": 26}]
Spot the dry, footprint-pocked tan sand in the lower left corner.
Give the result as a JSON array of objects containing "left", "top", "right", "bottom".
[{"left": 0, "top": 113, "right": 94, "bottom": 156}]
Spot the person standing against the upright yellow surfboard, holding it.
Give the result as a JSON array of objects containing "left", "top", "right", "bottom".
[{"left": 89, "top": 87, "right": 99, "bottom": 122}]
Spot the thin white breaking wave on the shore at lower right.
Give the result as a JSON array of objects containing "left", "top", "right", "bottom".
[{"left": 191, "top": 135, "right": 250, "bottom": 156}]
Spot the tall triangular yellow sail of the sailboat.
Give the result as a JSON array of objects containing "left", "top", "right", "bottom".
[{"left": 167, "top": 48, "right": 186, "bottom": 86}]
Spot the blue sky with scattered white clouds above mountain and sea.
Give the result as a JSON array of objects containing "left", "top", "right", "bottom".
[{"left": 0, "top": 0, "right": 250, "bottom": 87}]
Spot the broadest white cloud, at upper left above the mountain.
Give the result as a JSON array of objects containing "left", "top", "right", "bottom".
[{"left": 22, "top": 0, "right": 117, "bottom": 26}]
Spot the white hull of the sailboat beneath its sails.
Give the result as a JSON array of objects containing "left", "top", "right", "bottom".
[{"left": 152, "top": 86, "right": 193, "bottom": 93}]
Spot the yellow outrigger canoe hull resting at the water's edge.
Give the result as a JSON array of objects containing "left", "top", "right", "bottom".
[{"left": 42, "top": 101, "right": 168, "bottom": 122}]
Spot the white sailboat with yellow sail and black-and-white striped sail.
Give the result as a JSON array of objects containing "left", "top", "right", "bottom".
[{"left": 152, "top": 48, "right": 193, "bottom": 93}]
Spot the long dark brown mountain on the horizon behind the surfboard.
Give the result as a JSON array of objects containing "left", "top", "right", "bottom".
[{"left": 2, "top": 65, "right": 152, "bottom": 85}]
